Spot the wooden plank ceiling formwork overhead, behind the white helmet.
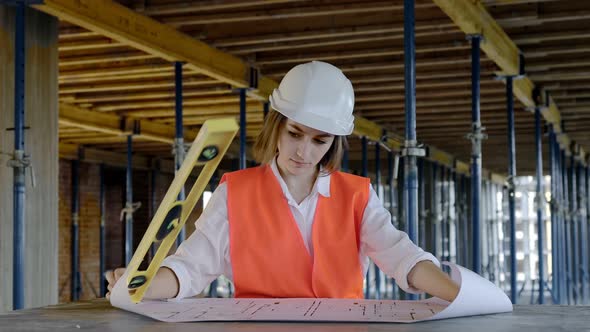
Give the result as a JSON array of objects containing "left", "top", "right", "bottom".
[{"left": 31, "top": 0, "right": 590, "bottom": 173}]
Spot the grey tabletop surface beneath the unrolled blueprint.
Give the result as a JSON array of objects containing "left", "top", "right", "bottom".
[{"left": 0, "top": 299, "right": 590, "bottom": 332}]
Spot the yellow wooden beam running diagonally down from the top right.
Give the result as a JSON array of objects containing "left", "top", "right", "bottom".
[{"left": 433, "top": 0, "right": 569, "bottom": 147}]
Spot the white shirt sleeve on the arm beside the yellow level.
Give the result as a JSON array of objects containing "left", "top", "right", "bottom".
[{"left": 162, "top": 183, "right": 232, "bottom": 299}]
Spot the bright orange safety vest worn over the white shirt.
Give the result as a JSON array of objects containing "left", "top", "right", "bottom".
[{"left": 222, "top": 165, "right": 370, "bottom": 298}]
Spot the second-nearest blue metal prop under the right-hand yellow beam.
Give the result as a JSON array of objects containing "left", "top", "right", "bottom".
[{"left": 506, "top": 76, "right": 518, "bottom": 303}]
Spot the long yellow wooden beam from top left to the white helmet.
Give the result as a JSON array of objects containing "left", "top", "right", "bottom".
[{"left": 34, "top": 0, "right": 270, "bottom": 100}]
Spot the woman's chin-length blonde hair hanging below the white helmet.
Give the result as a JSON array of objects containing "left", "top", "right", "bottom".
[{"left": 253, "top": 110, "right": 348, "bottom": 175}]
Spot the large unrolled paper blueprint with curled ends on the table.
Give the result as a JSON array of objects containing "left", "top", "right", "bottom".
[{"left": 111, "top": 263, "right": 512, "bottom": 323}]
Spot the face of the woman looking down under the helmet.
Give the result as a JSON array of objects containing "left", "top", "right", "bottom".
[{"left": 277, "top": 119, "right": 334, "bottom": 175}]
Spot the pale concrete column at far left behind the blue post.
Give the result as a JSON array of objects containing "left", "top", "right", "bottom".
[{"left": 0, "top": 5, "right": 59, "bottom": 312}]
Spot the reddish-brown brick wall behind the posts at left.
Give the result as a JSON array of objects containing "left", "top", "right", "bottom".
[{"left": 59, "top": 160, "right": 202, "bottom": 302}]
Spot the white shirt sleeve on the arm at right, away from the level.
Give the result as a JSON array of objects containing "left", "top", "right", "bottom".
[{"left": 360, "top": 187, "right": 440, "bottom": 294}]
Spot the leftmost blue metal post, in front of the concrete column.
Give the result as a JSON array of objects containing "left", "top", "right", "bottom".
[{"left": 12, "top": 3, "right": 26, "bottom": 310}]
